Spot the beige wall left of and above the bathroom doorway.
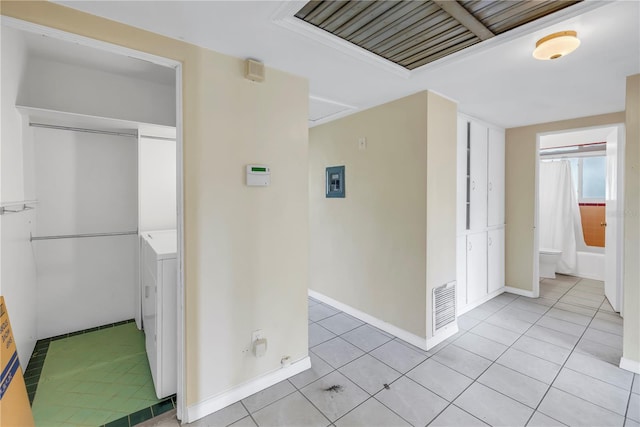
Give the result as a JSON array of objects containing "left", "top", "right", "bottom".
[{"left": 505, "top": 113, "right": 625, "bottom": 291}]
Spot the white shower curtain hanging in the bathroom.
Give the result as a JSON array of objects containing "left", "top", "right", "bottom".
[{"left": 539, "top": 160, "right": 583, "bottom": 274}]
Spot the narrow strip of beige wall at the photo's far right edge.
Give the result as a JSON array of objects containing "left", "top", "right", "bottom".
[{"left": 622, "top": 74, "right": 640, "bottom": 372}]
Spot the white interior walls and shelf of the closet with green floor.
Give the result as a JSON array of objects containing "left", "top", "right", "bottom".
[{"left": 0, "top": 25, "right": 176, "bottom": 412}]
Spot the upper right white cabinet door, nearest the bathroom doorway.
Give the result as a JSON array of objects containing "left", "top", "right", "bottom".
[{"left": 487, "top": 128, "right": 504, "bottom": 227}]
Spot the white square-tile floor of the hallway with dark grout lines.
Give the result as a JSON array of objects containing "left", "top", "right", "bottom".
[{"left": 145, "top": 276, "right": 640, "bottom": 427}]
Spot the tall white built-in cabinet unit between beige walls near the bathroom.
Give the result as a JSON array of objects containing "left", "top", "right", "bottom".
[{"left": 456, "top": 114, "right": 505, "bottom": 315}]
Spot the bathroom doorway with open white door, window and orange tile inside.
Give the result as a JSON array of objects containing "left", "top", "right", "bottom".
[{"left": 534, "top": 124, "right": 624, "bottom": 315}]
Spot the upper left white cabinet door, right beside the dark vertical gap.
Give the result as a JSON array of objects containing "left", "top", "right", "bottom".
[{"left": 469, "top": 121, "right": 488, "bottom": 230}]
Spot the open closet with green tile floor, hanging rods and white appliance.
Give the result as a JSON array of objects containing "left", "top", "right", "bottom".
[{"left": 0, "top": 17, "right": 184, "bottom": 425}]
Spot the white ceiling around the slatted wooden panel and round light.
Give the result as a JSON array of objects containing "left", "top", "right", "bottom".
[{"left": 50, "top": 0, "right": 640, "bottom": 127}]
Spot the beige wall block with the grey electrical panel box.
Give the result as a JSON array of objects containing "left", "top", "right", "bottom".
[{"left": 309, "top": 92, "right": 456, "bottom": 338}]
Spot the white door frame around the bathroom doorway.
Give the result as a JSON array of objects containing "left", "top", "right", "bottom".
[{"left": 532, "top": 123, "right": 625, "bottom": 310}]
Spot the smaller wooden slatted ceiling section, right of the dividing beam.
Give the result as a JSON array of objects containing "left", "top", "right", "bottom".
[{"left": 458, "top": 0, "right": 580, "bottom": 35}]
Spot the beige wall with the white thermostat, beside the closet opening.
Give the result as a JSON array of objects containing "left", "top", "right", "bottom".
[{"left": 1, "top": 1, "right": 309, "bottom": 412}]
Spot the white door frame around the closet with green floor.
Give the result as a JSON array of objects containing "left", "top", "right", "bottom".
[{"left": 0, "top": 16, "right": 186, "bottom": 419}]
